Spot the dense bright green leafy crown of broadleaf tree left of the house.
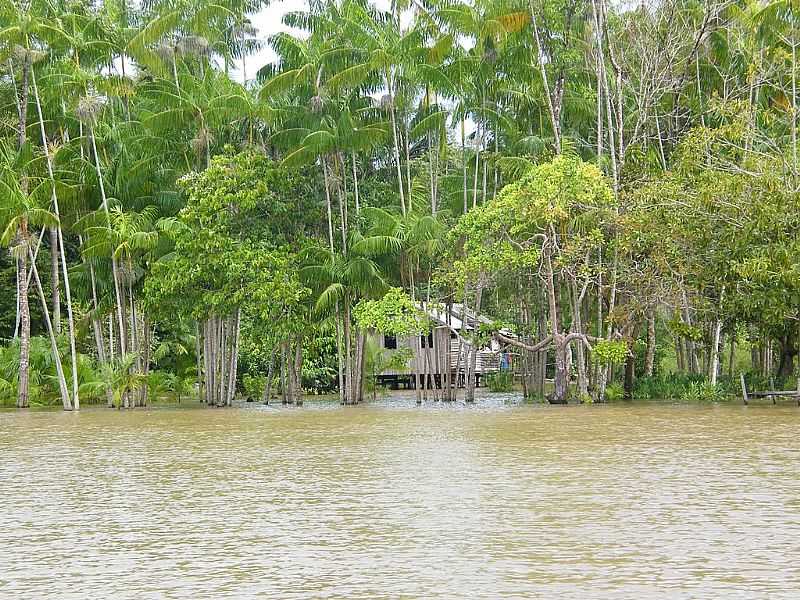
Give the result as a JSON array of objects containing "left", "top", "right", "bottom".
[{"left": 147, "top": 153, "right": 310, "bottom": 328}]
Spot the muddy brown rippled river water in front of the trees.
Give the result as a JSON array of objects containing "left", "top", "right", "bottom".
[{"left": 0, "top": 397, "right": 800, "bottom": 600}]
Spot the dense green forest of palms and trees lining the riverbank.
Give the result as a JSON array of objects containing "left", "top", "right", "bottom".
[{"left": 0, "top": 0, "right": 800, "bottom": 409}]
